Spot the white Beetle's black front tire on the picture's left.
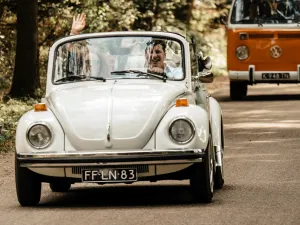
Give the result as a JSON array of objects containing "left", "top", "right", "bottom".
[{"left": 15, "top": 157, "right": 42, "bottom": 206}]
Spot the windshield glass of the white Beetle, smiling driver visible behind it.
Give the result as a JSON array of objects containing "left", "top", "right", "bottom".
[{"left": 53, "top": 36, "right": 184, "bottom": 84}]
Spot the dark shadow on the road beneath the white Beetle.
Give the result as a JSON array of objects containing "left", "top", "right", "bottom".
[{"left": 38, "top": 185, "right": 225, "bottom": 208}]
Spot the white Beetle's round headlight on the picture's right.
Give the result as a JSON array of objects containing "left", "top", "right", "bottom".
[{"left": 169, "top": 118, "right": 195, "bottom": 144}]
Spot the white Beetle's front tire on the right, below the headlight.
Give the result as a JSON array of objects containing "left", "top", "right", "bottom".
[{"left": 190, "top": 138, "right": 215, "bottom": 203}]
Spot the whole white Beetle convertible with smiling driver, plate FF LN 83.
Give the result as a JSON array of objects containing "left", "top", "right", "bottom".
[{"left": 15, "top": 32, "right": 224, "bottom": 206}]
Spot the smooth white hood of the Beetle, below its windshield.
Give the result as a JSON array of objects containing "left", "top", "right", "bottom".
[{"left": 47, "top": 81, "right": 186, "bottom": 151}]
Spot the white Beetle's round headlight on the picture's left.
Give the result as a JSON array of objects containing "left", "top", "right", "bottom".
[{"left": 27, "top": 124, "right": 52, "bottom": 149}]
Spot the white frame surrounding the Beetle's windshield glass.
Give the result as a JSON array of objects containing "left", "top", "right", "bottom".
[{"left": 51, "top": 32, "right": 187, "bottom": 85}]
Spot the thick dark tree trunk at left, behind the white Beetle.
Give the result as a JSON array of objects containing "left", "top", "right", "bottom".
[{"left": 9, "top": 0, "right": 39, "bottom": 97}]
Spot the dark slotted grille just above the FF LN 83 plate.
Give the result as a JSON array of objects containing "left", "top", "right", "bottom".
[{"left": 72, "top": 165, "right": 149, "bottom": 174}]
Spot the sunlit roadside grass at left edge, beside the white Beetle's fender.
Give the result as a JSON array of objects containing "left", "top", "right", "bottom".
[{"left": 0, "top": 92, "right": 38, "bottom": 153}]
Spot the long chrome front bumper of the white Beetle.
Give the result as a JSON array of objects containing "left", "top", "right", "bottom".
[{"left": 17, "top": 149, "right": 205, "bottom": 168}]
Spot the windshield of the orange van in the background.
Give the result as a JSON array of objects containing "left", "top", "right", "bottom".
[{"left": 231, "top": 0, "right": 300, "bottom": 25}]
